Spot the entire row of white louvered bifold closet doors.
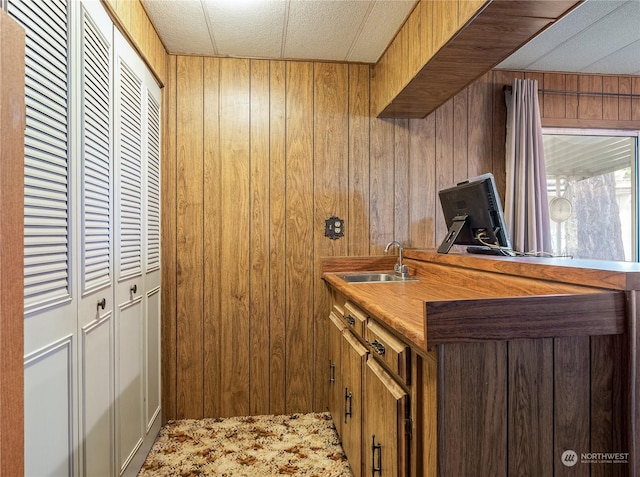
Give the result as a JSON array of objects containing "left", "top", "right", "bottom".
[{"left": 8, "top": 0, "right": 161, "bottom": 477}]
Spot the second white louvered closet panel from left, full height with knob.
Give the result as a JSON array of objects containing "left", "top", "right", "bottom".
[{"left": 76, "top": 1, "right": 115, "bottom": 477}]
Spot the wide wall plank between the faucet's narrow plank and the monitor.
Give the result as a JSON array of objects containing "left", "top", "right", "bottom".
[{"left": 408, "top": 114, "right": 440, "bottom": 248}]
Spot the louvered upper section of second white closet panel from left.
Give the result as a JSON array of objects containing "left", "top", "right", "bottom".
[{"left": 82, "top": 5, "right": 112, "bottom": 294}]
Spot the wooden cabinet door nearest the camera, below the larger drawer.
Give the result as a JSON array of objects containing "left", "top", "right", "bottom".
[{"left": 362, "top": 357, "right": 409, "bottom": 477}]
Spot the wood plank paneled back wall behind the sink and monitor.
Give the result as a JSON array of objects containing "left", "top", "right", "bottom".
[{"left": 163, "top": 56, "right": 504, "bottom": 418}]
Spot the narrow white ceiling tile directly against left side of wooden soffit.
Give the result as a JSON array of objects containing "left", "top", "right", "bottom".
[{"left": 346, "top": 0, "right": 417, "bottom": 63}]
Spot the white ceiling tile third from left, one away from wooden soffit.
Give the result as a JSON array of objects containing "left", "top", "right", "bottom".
[{"left": 283, "top": 0, "right": 369, "bottom": 61}]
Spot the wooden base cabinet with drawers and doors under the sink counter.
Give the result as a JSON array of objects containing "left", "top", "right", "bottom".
[{"left": 328, "top": 294, "right": 417, "bottom": 477}]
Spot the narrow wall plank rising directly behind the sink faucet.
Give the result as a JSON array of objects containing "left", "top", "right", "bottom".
[{"left": 393, "top": 119, "right": 410, "bottom": 243}]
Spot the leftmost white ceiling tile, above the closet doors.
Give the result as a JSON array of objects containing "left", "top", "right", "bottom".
[{"left": 144, "top": 0, "right": 217, "bottom": 56}]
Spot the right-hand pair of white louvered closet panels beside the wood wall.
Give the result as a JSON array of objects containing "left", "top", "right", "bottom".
[{"left": 114, "top": 27, "right": 160, "bottom": 474}]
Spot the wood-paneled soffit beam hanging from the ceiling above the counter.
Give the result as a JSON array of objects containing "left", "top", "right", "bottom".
[{"left": 371, "top": 0, "right": 580, "bottom": 118}]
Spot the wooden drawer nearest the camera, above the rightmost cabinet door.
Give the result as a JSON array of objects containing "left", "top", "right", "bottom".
[{"left": 365, "top": 320, "right": 411, "bottom": 385}]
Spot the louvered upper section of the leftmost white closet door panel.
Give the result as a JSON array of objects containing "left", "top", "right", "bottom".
[{"left": 8, "top": 0, "right": 70, "bottom": 313}]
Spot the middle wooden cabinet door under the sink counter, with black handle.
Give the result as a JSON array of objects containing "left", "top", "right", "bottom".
[{"left": 342, "top": 331, "right": 367, "bottom": 476}]
